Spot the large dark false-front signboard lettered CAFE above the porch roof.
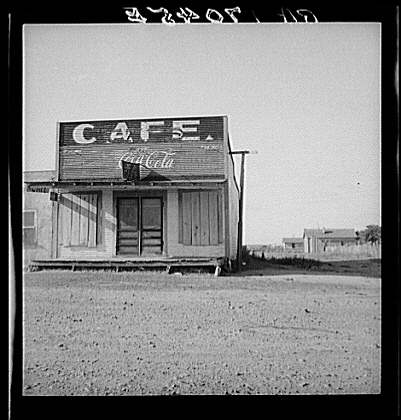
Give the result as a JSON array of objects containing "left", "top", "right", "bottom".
[{"left": 57, "top": 116, "right": 227, "bottom": 181}]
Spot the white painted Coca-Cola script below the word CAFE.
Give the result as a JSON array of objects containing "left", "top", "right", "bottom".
[{"left": 118, "top": 147, "right": 175, "bottom": 169}]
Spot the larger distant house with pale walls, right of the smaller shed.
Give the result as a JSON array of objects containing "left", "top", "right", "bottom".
[{"left": 303, "top": 228, "right": 357, "bottom": 253}]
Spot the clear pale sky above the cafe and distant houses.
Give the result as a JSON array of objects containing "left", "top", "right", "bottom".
[{"left": 23, "top": 23, "right": 381, "bottom": 244}]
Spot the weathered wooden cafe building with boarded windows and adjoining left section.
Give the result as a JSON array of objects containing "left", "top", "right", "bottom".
[{"left": 24, "top": 116, "right": 239, "bottom": 271}]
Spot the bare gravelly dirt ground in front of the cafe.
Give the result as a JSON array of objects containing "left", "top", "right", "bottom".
[{"left": 23, "top": 272, "right": 381, "bottom": 395}]
